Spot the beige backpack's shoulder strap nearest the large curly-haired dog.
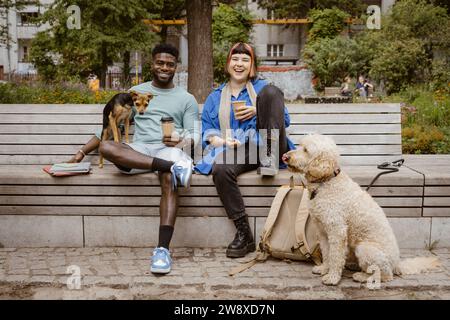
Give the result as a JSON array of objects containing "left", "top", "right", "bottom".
[{"left": 291, "top": 188, "right": 320, "bottom": 265}]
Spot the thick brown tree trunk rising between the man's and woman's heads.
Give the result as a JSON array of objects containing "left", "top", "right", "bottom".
[{"left": 186, "top": 0, "right": 214, "bottom": 103}]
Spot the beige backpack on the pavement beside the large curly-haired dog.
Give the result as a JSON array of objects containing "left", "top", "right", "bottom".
[{"left": 229, "top": 177, "right": 322, "bottom": 275}]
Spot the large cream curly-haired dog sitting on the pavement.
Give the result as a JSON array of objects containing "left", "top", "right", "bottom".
[{"left": 283, "top": 134, "right": 438, "bottom": 285}]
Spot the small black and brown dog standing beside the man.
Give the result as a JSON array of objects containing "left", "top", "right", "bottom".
[{"left": 98, "top": 91, "right": 153, "bottom": 168}]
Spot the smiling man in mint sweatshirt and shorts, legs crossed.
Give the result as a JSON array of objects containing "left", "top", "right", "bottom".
[{"left": 70, "top": 44, "right": 200, "bottom": 273}]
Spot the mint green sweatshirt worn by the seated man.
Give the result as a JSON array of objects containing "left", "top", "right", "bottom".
[{"left": 96, "top": 82, "right": 201, "bottom": 144}]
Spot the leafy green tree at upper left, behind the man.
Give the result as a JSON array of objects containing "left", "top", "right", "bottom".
[{"left": 30, "top": 0, "right": 161, "bottom": 86}]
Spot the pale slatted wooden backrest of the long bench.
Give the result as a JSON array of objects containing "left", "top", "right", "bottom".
[{"left": 0, "top": 103, "right": 402, "bottom": 165}]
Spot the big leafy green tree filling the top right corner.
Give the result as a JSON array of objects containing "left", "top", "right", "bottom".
[{"left": 358, "top": 0, "right": 450, "bottom": 93}]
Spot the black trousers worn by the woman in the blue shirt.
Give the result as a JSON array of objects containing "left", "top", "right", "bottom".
[{"left": 212, "top": 85, "right": 288, "bottom": 220}]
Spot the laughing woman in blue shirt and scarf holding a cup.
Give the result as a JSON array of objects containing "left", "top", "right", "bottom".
[{"left": 195, "top": 43, "right": 295, "bottom": 258}]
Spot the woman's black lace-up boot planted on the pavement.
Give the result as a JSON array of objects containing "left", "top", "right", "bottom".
[{"left": 227, "top": 216, "right": 256, "bottom": 258}]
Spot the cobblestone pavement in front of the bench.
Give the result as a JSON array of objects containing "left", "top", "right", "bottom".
[{"left": 0, "top": 248, "right": 450, "bottom": 299}]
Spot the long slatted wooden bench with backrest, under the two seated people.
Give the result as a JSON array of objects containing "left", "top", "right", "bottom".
[{"left": 0, "top": 104, "right": 450, "bottom": 247}]
